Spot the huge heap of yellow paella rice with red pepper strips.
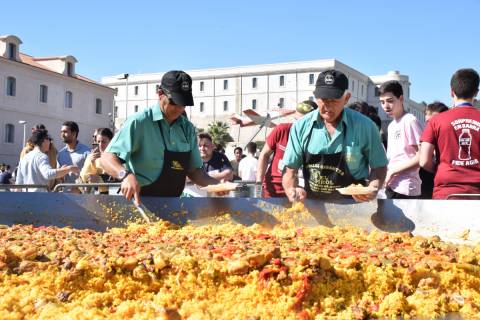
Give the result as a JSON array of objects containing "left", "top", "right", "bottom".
[{"left": 0, "top": 210, "right": 480, "bottom": 319}]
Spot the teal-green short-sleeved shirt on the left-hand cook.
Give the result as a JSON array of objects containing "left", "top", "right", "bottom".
[{"left": 106, "top": 103, "right": 203, "bottom": 186}]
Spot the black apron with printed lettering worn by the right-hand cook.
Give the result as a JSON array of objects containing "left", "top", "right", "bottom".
[{"left": 303, "top": 123, "right": 365, "bottom": 199}]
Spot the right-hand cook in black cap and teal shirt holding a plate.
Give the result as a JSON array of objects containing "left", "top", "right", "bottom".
[{"left": 282, "top": 70, "right": 387, "bottom": 201}]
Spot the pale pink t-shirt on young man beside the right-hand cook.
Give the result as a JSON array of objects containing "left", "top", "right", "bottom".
[{"left": 387, "top": 113, "right": 422, "bottom": 196}]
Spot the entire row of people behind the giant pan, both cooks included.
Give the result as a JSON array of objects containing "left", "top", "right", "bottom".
[{"left": 0, "top": 69, "right": 480, "bottom": 203}]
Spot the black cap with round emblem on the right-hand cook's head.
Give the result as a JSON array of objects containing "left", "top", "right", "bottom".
[{"left": 313, "top": 70, "right": 348, "bottom": 99}]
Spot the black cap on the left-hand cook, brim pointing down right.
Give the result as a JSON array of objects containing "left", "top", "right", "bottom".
[{"left": 160, "top": 70, "right": 193, "bottom": 106}]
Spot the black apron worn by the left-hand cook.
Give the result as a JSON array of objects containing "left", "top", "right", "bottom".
[{"left": 140, "top": 122, "right": 190, "bottom": 197}]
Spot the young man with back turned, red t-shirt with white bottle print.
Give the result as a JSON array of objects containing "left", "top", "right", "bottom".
[{"left": 420, "top": 69, "right": 480, "bottom": 199}]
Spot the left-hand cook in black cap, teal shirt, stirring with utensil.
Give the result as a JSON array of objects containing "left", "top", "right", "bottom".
[{"left": 101, "top": 71, "right": 222, "bottom": 203}]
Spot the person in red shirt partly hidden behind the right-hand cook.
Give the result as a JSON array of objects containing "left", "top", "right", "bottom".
[{"left": 256, "top": 100, "right": 318, "bottom": 198}]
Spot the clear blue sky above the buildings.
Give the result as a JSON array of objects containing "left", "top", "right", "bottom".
[{"left": 0, "top": 0, "right": 480, "bottom": 104}]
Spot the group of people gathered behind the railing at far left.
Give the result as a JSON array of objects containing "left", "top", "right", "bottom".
[{"left": 0, "top": 121, "right": 113, "bottom": 193}]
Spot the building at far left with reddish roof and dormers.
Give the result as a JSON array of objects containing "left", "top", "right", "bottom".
[{"left": 0, "top": 35, "right": 115, "bottom": 167}]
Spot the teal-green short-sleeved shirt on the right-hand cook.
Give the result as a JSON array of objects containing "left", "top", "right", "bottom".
[{"left": 282, "top": 108, "right": 388, "bottom": 179}]
